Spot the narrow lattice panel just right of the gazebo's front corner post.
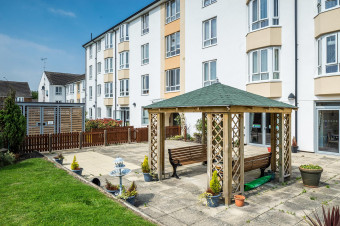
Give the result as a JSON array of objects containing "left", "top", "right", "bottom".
[{"left": 231, "top": 114, "right": 243, "bottom": 194}]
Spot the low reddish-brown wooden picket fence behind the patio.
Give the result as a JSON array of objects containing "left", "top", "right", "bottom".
[{"left": 21, "top": 126, "right": 181, "bottom": 153}]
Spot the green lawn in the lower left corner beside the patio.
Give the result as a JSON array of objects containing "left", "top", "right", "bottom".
[{"left": 0, "top": 159, "right": 152, "bottom": 225}]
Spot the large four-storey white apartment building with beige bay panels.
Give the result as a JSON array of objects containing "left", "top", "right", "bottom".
[{"left": 83, "top": 0, "right": 340, "bottom": 154}]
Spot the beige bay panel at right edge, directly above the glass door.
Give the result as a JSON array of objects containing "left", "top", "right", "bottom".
[{"left": 314, "top": 75, "right": 340, "bottom": 96}]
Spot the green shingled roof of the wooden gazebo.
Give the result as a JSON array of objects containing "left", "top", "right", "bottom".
[{"left": 144, "top": 83, "right": 296, "bottom": 109}]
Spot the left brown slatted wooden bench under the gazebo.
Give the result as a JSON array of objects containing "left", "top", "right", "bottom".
[{"left": 168, "top": 145, "right": 207, "bottom": 178}]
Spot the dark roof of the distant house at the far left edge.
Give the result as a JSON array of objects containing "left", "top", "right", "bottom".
[{"left": 0, "top": 81, "right": 32, "bottom": 98}]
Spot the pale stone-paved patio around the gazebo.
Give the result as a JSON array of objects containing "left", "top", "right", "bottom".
[{"left": 46, "top": 140, "right": 340, "bottom": 226}]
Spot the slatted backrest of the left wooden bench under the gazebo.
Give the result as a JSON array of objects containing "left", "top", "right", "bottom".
[{"left": 169, "top": 145, "right": 207, "bottom": 161}]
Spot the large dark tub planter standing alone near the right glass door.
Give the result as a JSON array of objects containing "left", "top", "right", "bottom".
[{"left": 299, "top": 164, "right": 323, "bottom": 188}]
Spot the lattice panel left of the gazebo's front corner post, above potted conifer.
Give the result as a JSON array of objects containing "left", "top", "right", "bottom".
[{"left": 211, "top": 114, "right": 223, "bottom": 187}]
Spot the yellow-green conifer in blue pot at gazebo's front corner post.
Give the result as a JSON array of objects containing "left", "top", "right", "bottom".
[{"left": 200, "top": 171, "right": 221, "bottom": 207}]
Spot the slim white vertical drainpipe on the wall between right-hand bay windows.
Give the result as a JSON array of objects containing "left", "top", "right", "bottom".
[{"left": 295, "top": 0, "right": 298, "bottom": 142}]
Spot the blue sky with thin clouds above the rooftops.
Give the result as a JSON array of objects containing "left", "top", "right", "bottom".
[{"left": 0, "top": 0, "right": 153, "bottom": 90}]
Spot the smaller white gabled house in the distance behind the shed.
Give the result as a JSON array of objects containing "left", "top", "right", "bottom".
[{"left": 38, "top": 71, "right": 86, "bottom": 103}]
